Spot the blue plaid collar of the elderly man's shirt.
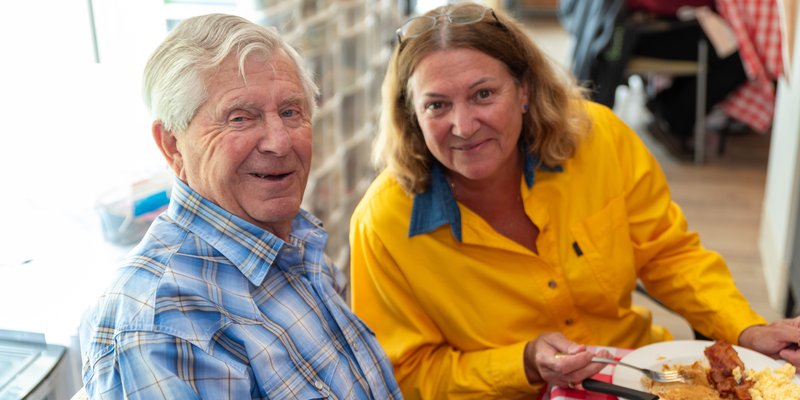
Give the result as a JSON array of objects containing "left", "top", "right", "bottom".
[{"left": 167, "top": 179, "right": 327, "bottom": 286}]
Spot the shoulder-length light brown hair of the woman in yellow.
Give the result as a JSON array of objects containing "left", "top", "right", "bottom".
[{"left": 373, "top": 3, "right": 589, "bottom": 193}]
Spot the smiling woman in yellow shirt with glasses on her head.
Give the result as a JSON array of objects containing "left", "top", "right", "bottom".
[{"left": 350, "top": 3, "right": 800, "bottom": 399}]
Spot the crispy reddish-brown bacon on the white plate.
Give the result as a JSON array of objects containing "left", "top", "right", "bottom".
[{"left": 705, "top": 340, "right": 753, "bottom": 400}]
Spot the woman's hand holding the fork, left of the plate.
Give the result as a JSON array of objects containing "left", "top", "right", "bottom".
[{"left": 524, "top": 332, "right": 611, "bottom": 388}]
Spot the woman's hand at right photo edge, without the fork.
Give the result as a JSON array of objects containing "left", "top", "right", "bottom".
[{"left": 739, "top": 317, "right": 800, "bottom": 367}]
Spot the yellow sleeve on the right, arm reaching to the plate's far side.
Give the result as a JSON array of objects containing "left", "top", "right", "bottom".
[{"left": 601, "top": 104, "right": 766, "bottom": 344}]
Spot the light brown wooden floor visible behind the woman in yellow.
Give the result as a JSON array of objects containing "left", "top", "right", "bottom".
[{"left": 525, "top": 17, "right": 780, "bottom": 339}]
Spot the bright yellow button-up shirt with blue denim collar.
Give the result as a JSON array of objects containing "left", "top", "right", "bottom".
[{"left": 350, "top": 103, "right": 765, "bottom": 399}]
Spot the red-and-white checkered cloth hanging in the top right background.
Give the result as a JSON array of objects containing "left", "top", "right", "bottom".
[{"left": 716, "top": 0, "right": 783, "bottom": 133}]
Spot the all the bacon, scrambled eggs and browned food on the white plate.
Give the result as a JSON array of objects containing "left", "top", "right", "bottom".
[{"left": 642, "top": 342, "right": 800, "bottom": 400}]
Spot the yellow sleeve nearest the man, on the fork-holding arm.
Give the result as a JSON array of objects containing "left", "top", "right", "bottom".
[{"left": 350, "top": 215, "right": 543, "bottom": 399}]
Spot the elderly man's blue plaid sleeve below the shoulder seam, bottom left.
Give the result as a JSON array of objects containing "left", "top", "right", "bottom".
[{"left": 84, "top": 332, "right": 252, "bottom": 400}]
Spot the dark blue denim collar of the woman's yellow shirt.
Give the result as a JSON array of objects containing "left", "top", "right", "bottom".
[{"left": 408, "top": 154, "right": 564, "bottom": 242}]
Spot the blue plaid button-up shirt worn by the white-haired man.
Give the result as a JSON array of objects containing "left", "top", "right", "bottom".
[{"left": 81, "top": 180, "right": 401, "bottom": 399}]
